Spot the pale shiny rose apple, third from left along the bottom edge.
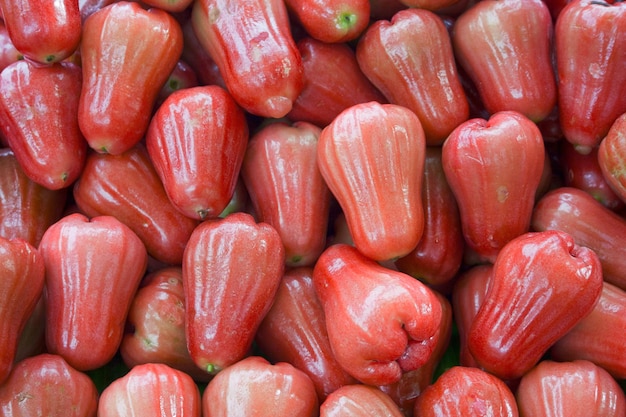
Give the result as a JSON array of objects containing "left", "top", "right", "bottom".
[{"left": 202, "top": 356, "right": 319, "bottom": 417}]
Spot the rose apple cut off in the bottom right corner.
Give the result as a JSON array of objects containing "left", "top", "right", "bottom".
[{"left": 515, "top": 360, "right": 626, "bottom": 417}]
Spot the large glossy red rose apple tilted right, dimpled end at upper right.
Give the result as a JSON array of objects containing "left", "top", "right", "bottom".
[{"left": 467, "top": 230, "right": 603, "bottom": 380}]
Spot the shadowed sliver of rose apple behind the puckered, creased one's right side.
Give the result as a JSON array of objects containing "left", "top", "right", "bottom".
[{"left": 378, "top": 291, "right": 450, "bottom": 416}]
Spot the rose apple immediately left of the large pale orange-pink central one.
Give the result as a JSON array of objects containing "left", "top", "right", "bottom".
[{"left": 241, "top": 122, "right": 331, "bottom": 267}]
